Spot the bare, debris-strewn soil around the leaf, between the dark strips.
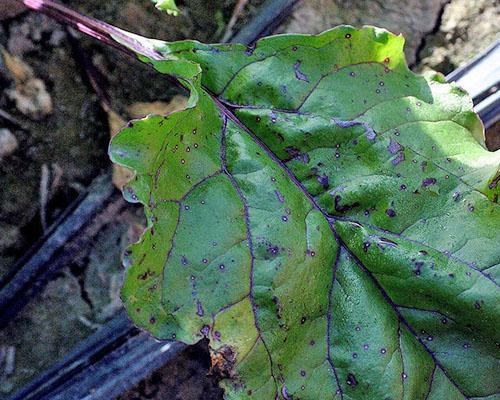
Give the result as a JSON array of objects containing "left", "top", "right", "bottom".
[{"left": 0, "top": 0, "right": 500, "bottom": 400}]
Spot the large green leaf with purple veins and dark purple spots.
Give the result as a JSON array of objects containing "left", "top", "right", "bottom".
[{"left": 110, "top": 26, "right": 500, "bottom": 400}]
